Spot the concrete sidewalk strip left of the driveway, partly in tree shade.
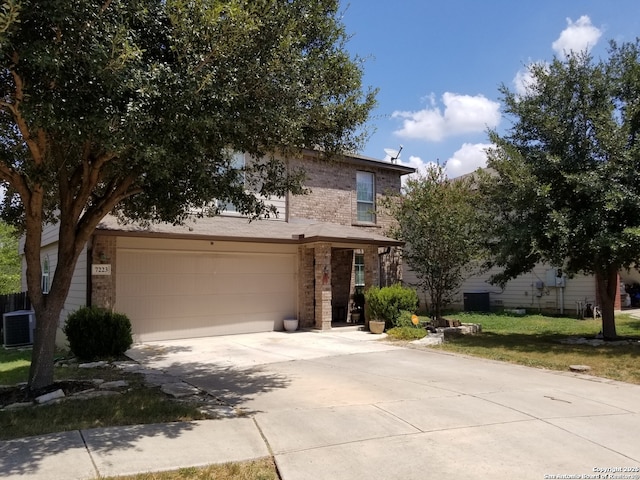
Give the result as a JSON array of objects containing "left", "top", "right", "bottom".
[{"left": 0, "top": 418, "right": 269, "bottom": 480}]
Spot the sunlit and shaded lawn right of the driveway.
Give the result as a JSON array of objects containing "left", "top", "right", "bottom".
[{"left": 433, "top": 313, "right": 640, "bottom": 384}]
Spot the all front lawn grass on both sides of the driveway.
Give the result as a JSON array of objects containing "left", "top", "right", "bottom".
[{"left": 0, "top": 313, "right": 640, "bottom": 480}]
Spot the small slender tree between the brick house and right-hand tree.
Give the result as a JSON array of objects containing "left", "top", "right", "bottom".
[{"left": 389, "top": 165, "right": 482, "bottom": 320}]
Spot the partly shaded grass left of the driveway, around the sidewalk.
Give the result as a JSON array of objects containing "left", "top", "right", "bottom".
[{"left": 0, "top": 347, "right": 279, "bottom": 480}]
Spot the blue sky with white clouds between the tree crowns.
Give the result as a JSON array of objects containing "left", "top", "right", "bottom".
[{"left": 341, "top": 0, "right": 640, "bottom": 177}]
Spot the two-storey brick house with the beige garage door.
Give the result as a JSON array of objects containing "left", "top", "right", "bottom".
[{"left": 23, "top": 151, "right": 414, "bottom": 343}]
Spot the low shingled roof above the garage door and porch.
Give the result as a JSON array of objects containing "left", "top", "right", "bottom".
[{"left": 96, "top": 215, "right": 404, "bottom": 246}]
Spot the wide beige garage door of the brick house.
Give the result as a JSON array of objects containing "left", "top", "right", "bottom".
[{"left": 116, "top": 250, "right": 297, "bottom": 342}]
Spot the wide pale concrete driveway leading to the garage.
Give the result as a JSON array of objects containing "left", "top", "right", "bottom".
[{"left": 130, "top": 331, "right": 640, "bottom": 480}]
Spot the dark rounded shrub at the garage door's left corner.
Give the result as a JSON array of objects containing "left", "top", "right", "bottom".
[{"left": 63, "top": 307, "right": 133, "bottom": 360}]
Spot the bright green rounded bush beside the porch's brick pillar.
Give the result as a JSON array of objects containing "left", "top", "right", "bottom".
[{"left": 364, "top": 283, "right": 418, "bottom": 329}]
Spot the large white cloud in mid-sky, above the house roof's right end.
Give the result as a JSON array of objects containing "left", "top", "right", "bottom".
[{"left": 392, "top": 92, "right": 500, "bottom": 141}]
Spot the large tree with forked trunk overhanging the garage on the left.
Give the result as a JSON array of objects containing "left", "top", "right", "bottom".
[{"left": 0, "top": 0, "right": 375, "bottom": 388}]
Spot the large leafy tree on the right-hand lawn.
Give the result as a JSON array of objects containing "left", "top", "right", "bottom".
[{"left": 482, "top": 41, "right": 640, "bottom": 338}]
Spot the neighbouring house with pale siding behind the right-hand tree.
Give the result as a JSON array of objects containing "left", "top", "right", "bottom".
[{"left": 403, "top": 264, "right": 624, "bottom": 316}]
